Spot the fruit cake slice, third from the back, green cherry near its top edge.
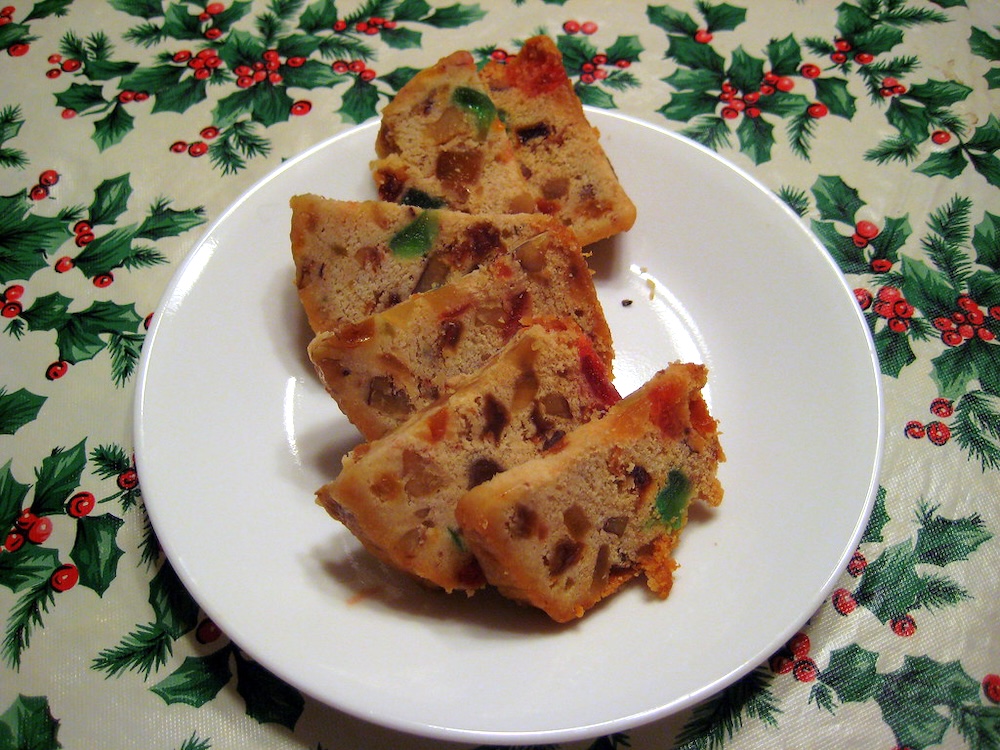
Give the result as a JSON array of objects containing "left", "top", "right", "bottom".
[{"left": 291, "top": 195, "right": 558, "bottom": 332}]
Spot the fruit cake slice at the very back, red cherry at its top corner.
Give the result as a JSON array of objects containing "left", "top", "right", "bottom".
[{"left": 480, "top": 36, "right": 636, "bottom": 245}]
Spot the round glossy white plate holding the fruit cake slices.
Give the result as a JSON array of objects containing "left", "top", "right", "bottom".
[{"left": 135, "top": 109, "right": 882, "bottom": 744}]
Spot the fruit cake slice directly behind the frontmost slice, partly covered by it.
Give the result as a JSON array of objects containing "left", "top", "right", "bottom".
[{"left": 317, "top": 320, "right": 619, "bottom": 593}]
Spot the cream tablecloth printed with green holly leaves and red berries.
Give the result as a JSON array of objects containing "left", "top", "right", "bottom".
[{"left": 0, "top": 0, "right": 1000, "bottom": 750}]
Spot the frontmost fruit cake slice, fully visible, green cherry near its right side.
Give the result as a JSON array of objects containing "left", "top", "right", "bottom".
[{"left": 456, "top": 363, "right": 724, "bottom": 622}]
